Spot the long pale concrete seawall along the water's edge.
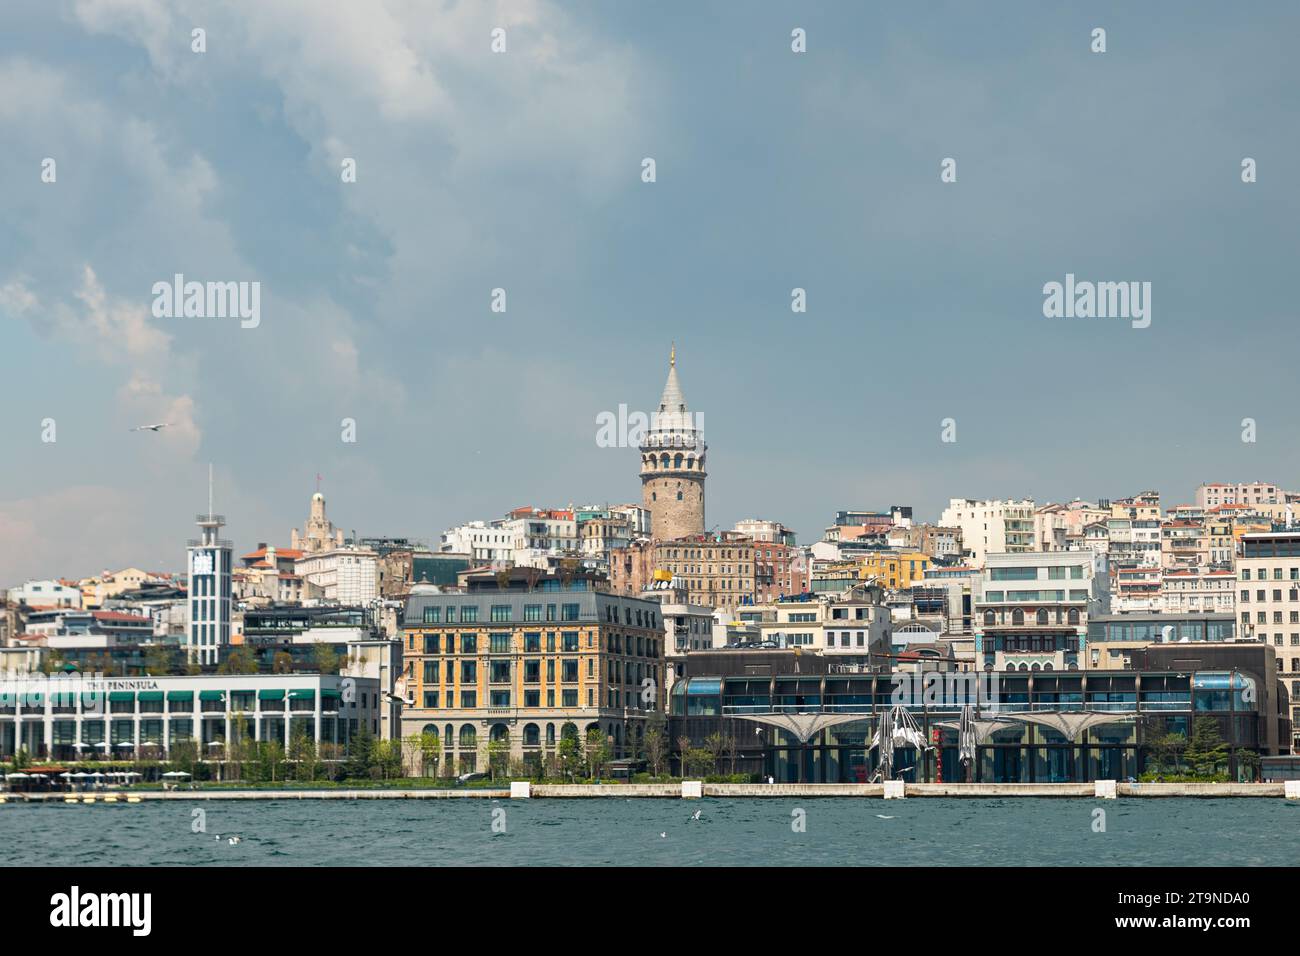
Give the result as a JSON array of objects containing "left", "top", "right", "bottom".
[{"left": 0, "top": 780, "right": 1300, "bottom": 805}]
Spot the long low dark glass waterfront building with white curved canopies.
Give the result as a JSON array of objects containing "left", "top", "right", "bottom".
[{"left": 670, "top": 645, "right": 1288, "bottom": 783}]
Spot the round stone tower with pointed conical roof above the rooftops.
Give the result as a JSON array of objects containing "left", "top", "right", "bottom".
[{"left": 641, "top": 346, "right": 709, "bottom": 541}]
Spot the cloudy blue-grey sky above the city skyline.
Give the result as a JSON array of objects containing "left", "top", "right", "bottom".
[{"left": 0, "top": 0, "right": 1300, "bottom": 584}]
